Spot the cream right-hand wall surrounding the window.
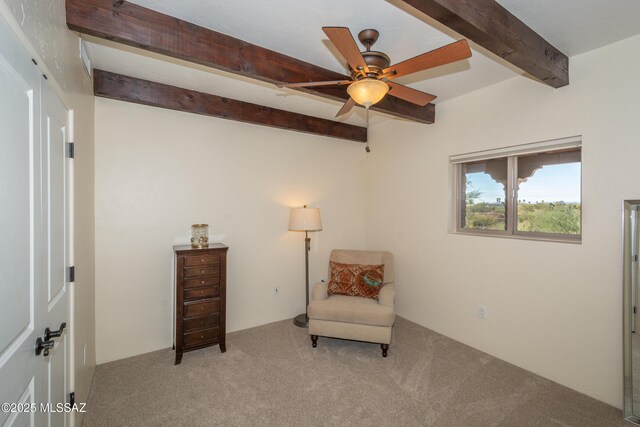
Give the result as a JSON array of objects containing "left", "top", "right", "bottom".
[{"left": 366, "top": 37, "right": 640, "bottom": 407}]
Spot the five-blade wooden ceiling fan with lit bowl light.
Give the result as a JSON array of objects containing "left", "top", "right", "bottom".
[{"left": 276, "top": 27, "right": 471, "bottom": 117}]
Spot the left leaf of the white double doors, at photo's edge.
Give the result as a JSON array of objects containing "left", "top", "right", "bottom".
[{"left": 0, "top": 14, "right": 43, "bottom": 425}]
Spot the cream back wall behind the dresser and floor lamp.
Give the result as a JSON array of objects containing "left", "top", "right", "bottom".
[{"left": 95, "top": 98, "right": 366, "bottom": 363}]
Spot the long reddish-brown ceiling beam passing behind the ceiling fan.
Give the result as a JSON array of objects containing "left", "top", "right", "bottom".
[{"left": 66, "top": 0, "right": 435, "bottom": 123}]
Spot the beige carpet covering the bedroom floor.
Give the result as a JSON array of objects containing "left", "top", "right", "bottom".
[{"left": 84, "top": 318, "right": 628, "bottom": 427}]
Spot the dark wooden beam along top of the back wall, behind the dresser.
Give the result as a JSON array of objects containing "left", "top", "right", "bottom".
[{"left": 93, "top": 70, "right": 367, "bottom": 142}]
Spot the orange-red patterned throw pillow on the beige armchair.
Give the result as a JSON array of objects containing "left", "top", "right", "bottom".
[{"left": 327, "top": 261, "right": 384, "bottom": 299}]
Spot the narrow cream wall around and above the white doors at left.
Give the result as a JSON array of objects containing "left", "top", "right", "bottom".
[{"left": 0, "top": 0, "right": 95, "bottom": 424}]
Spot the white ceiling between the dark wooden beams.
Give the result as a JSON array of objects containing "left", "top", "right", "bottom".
[{"left": 89, "top": 0, "right": 640, "bottom": 124}]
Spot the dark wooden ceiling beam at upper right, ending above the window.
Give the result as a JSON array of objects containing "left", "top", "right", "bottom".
[{"left": 401, "top": 0, "right": 569, "bottom": 88}]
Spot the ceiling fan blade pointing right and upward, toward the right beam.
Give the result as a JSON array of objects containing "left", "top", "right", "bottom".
[{"left": 382, "top": 39, "right": 471, "bottom": 79}]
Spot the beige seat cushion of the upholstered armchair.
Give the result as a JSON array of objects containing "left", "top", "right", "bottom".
[{"left": 308, "top": 295, "right": 396, "bottom": 326}]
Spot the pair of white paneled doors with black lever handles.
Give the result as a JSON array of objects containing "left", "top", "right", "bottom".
[{"left": 0, "top": 18, "right": 69, "bottom": 426}]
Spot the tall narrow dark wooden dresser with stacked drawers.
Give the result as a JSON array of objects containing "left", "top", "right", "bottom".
[{"left": 173, "top": 243, "right": 229, "bottom": 365}]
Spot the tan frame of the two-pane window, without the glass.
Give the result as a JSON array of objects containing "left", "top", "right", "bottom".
[{"left": 450, "top": 140, "right": 583, "bottom": 244}]
